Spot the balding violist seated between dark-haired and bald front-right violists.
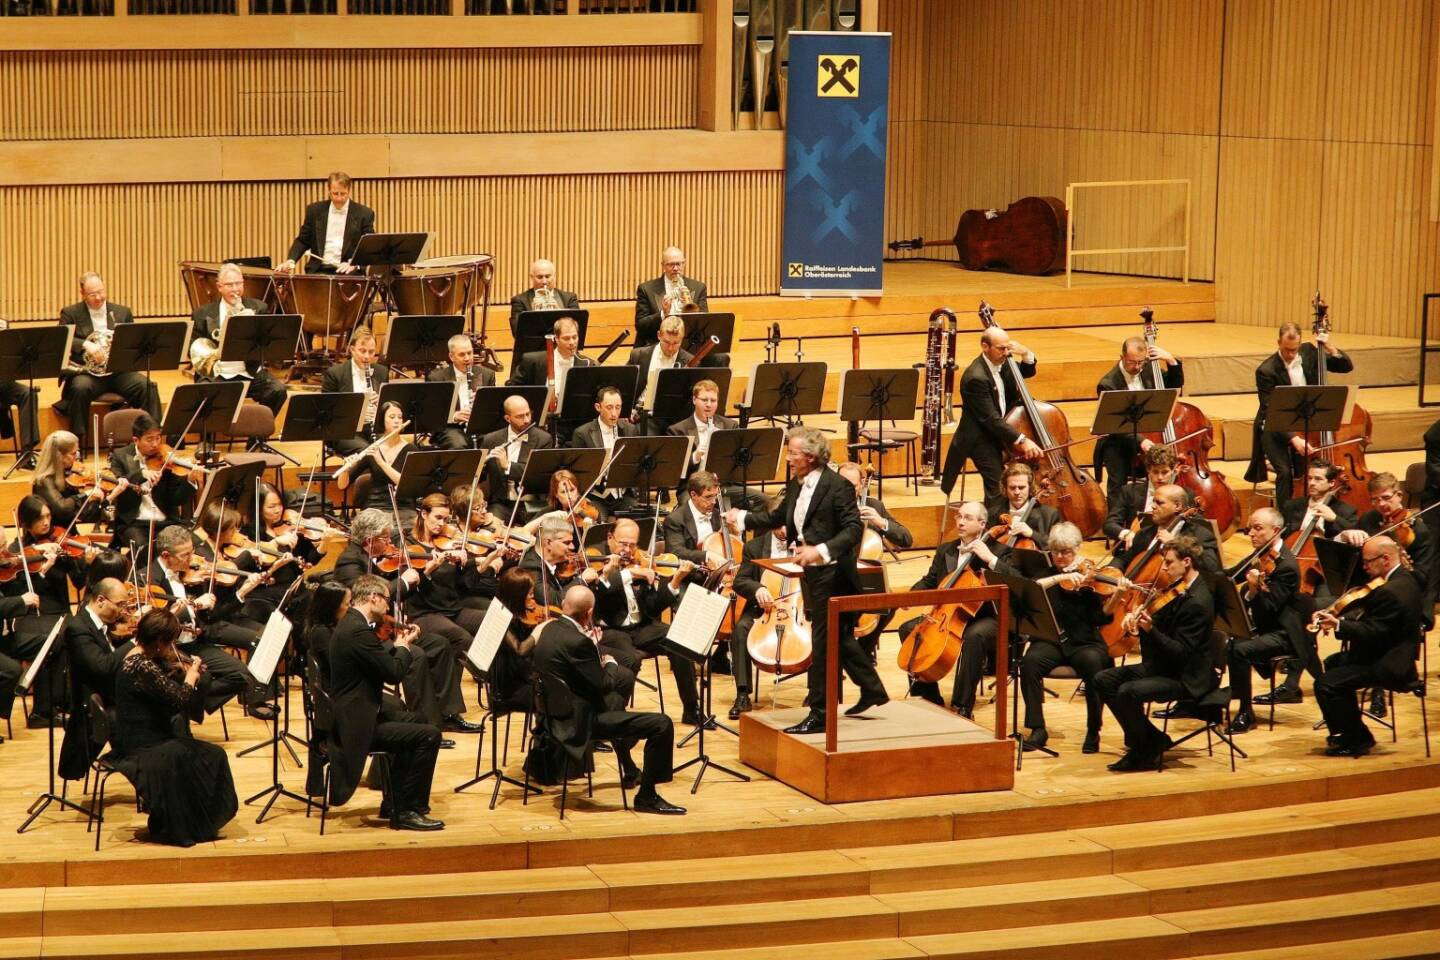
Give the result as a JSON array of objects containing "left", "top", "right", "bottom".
[{"left": 1225, "top": 501, "right": 1315, "bottom": 734}]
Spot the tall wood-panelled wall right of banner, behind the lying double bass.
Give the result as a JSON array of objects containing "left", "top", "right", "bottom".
[{"left": 881, "top": 0, "right": 1440, "bottom": 337}]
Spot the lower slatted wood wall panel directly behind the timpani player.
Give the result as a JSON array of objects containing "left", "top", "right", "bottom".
[{"left": 0, "top": 170, "right": 782, "bottom": 320}]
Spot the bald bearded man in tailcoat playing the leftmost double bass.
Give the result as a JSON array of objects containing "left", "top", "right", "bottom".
[{"left": 940, "top": 327, "right": 1041, "bottom": 499}]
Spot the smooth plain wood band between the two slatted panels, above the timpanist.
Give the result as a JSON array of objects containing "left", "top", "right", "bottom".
[{"left": 0, "top": 130, "right": 785, "bottom": 186}]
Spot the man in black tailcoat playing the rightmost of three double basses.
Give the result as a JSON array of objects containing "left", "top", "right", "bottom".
[{"left": 1246, "top": 322, "right": 1355, "bottom": 511}]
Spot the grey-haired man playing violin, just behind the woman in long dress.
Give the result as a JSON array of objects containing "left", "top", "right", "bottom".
[{"left": 147, "top": 525, "right": 275, "bottom": 721}]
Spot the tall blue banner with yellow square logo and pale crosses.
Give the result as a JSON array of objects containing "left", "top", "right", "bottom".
[{"left": 780, "top": 30, "right": 890, "bottom": 296}]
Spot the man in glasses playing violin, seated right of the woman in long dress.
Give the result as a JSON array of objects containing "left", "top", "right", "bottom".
[{"left": 325, "top": 574, "right": 445, "bottom": 830}]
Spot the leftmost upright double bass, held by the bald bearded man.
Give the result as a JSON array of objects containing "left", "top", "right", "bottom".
[{"left": 979, "top": 301, "right": 1106, "bottom": 537}]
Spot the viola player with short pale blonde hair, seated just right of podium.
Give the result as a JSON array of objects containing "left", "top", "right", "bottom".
[{"left": 1020, "top": 521, "right": 1113, "bottom": 753}]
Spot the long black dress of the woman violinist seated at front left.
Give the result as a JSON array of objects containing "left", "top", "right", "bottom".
[{"left": 115, "top": 655, "right": 239, "bottom": 846}]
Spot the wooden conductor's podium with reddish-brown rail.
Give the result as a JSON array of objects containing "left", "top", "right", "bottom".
[{"left": 740, "top": 578, "right": 1015, "bottom": 803}]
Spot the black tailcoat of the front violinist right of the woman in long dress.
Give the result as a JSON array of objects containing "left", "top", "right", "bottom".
[{"left": 328, "top": 610, "right": 412, "bottom": 803}]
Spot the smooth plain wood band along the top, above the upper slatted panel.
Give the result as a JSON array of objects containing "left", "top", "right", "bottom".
[{"left": 0, "top": 13, "right": 700, "bottom": 50}]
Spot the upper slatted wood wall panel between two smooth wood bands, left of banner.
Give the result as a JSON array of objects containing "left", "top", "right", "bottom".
[{"left": 0, "top": 46, "right": 700, "bottom": 140}]
